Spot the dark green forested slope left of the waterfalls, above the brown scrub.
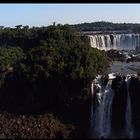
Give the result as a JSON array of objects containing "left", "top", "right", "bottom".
[{"left": 0, "top": 25, "right": 108, "bottom": 138}]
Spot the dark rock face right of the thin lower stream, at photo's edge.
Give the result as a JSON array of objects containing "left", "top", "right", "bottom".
[{"left": 129, "top": 77, "right": 140, "bottom": 133}]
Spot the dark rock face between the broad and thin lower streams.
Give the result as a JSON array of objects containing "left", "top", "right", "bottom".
[{"left": 111, "top": 76, "right": 127, "bottom": 133}]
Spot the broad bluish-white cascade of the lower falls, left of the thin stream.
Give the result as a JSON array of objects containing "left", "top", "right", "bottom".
[{"left": 94, "top": 75, "right": 114, "bottom": 138}]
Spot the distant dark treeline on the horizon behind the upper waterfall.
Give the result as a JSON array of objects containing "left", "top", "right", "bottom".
[{"left": 71, "top": 21, "right": 140, "bottom": 33}]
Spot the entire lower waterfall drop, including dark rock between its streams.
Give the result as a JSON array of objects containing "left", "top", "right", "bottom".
[{"left": 91, "top": 75, "right": 140, "bottom": 138}]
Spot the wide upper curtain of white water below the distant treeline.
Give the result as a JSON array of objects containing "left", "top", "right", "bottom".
[{"left": 88, "top": 34, "right": 140, "bottom": 50}]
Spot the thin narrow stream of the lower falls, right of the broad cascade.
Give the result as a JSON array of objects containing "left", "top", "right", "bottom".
[{"left": 125, "top": 75, "right": 134, "bottom": 138}]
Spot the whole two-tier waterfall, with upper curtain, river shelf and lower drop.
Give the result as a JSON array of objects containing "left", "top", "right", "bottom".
[{"left": 85, "top": 32, "right": 140, "bottom": 138}]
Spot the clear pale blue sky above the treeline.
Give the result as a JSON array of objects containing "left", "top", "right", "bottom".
[{"left": 0, "top": 3, "right": 140, "bottom": 27}]
